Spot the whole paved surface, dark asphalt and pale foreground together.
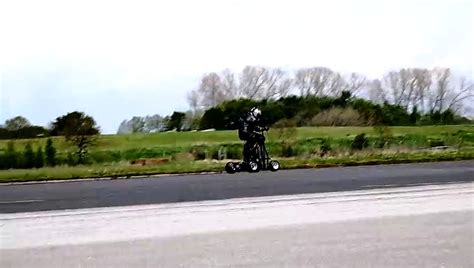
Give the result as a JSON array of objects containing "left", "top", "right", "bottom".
[{"left": 0, "top": 161, "right": 474, "bottom": 268}]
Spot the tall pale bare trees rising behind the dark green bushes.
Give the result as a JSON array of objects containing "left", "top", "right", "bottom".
[{"left": 187, "top": 66, "right": 474, "bottom": 114}]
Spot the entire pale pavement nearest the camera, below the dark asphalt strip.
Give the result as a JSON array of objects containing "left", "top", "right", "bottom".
[{"left": 0, "top": 182, "right": 474, "bottom": 267}]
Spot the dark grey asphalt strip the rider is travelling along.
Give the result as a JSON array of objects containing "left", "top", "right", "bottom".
[{"left": 0, "top": 161, "right": 474, "bottom": 213}]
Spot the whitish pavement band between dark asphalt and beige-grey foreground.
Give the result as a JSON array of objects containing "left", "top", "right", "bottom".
[{"left": 0, "top": 183, "right": 474, "bottom": 249}]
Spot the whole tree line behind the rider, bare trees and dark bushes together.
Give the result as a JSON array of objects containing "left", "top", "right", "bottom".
[{"left": 118, "top": 66, "right": 474, "bottom": 134}]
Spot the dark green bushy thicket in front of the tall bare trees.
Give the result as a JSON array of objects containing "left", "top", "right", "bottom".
[{"left": 199, "top": 91, "right": 472, "bottom": 130}]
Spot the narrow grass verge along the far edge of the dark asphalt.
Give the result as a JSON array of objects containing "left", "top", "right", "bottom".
[{"left": 0, "top": 150, "right": 474, "bottom": 183}]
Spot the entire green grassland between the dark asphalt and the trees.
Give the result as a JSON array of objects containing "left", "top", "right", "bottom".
[{"left": 0, "top": 125, "right": 474, "bottom": 182}]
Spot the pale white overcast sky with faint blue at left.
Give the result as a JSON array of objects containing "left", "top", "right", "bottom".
[{"left": 0, "top": 0, "right": 473, "bottom": 133}]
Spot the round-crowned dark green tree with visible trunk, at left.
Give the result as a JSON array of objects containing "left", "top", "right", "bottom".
[{"left": 51, "top": 112, "right": 100, "bottom": 164}]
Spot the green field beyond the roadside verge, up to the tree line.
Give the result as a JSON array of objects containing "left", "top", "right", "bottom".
[{"left": 0, "top": 125, "right": 474, "bottom": 163}]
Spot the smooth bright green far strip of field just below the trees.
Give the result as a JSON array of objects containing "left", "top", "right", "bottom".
[{"left": 0, "top": 125, "right": 474, "bottom": 152}]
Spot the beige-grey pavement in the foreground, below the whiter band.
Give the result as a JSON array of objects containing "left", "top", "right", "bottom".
[{"left": 0, "top": 212, "right": 474, "bottom": 268}]
